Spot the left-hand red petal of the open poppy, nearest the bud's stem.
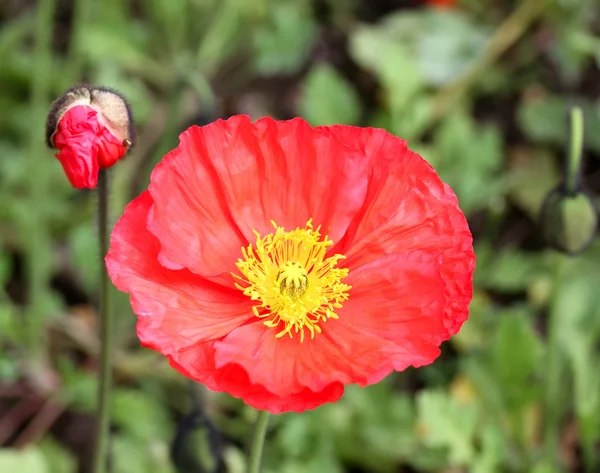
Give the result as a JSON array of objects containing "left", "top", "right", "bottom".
[{"left": 106, "top": 192, "right": 253, "bottom": 353}]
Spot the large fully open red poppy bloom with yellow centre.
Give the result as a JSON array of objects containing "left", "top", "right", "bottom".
[{"left": 106, "top": 116, "right": 475, "bottom": 413}]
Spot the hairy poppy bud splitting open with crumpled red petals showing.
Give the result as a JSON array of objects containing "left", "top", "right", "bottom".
[{"left": 46, "top": 85, "right": 135, "bottom": 189}]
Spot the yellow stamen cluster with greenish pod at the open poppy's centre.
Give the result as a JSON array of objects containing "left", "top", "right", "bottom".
[{"left": 233, "top": 220, "right": 350, "bottom": 342}]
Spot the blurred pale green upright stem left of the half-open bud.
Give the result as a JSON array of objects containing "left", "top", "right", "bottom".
[{"left": 24, "top": 0, "right": 56, "bottom": 364}]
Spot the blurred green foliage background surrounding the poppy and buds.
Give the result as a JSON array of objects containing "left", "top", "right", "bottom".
[{"left": 0, "top": 0, "right": 600, "bottom": 473}]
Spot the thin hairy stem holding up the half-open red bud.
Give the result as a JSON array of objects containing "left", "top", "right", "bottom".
[{"left": 94, "top": 169, "right": 113, "bottom": 473}]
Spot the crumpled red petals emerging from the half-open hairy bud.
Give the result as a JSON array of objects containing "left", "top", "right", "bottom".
[{"left": 54, "top": 105, "right": 127, "bottom": 189}]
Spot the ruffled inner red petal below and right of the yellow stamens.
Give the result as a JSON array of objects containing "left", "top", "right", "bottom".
[{"left": 215, "top": 253, "right": 445, "bottom": 396}]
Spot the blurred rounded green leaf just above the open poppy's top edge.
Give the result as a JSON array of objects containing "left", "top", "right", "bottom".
[{"left": 300, "top": 64, "right": 360, "bottom": 125}]
